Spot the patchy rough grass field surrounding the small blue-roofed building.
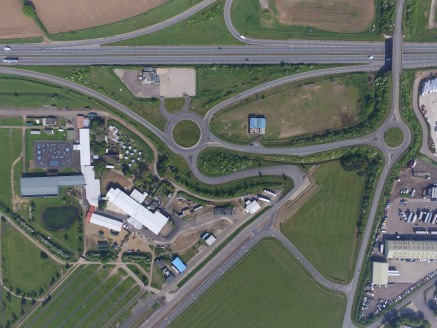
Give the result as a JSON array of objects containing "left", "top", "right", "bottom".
[{"left": 211, "top": 74, "right": 367, "bottom": 142}]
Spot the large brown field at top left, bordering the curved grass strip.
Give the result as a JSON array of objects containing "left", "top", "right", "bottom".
[{"left": 31, "top": 0, "right": 166, "bottom": 34}]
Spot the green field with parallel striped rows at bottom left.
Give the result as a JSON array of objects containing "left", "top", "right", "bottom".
[{"left": 23, "top": 264, "right": 140, "bottom": 328}]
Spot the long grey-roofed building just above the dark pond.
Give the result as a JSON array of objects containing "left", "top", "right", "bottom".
[{"left": 20, "top": 175, "right": 85, "bottom": 197}]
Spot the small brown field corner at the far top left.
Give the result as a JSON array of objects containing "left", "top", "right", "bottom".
[{"left": 0, "top": 0, "right": 42, "bottom": 39}]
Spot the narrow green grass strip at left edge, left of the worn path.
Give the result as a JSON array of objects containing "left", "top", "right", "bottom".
[{"left": 0, "top": 129, "right": 22, "bottom": 207}]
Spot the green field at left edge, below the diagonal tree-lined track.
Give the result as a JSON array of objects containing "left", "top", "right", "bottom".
[{"left": 1, "top": 221, "right": 65, "bottom": 296}]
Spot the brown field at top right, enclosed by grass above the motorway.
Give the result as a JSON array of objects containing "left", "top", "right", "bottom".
[{"left": 275, "top": 0, "right": 375, "bottom": 33}]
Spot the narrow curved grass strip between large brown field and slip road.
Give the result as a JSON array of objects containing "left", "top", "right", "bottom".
[{"left": 48, "top": 0, "right": 200, "bottom": 41}]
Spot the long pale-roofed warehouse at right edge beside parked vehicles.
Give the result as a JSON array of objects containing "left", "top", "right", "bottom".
[{"left": 384, "top": 240, "right": 437, "bottom": 260}]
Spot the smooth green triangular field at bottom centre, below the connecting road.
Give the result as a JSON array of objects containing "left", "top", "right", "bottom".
[{"left": 172, "top": 240, "right": 346, "bottom": 328}]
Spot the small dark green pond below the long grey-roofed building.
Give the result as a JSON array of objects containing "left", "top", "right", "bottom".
[{"left": 42, "top": 206, "right": 79, "bottom": 230}]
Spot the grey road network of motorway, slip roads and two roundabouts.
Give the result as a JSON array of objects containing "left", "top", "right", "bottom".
[{"left": 0, "top": 0, "right": 437, "bottom": 327}]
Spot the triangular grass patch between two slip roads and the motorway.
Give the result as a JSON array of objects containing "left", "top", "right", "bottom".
[{"left": 111, "top": 0, "right": 241, "bottom": 46}]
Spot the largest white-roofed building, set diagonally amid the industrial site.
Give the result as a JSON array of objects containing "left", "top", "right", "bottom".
[{"left": 106, "top": 188, "right": 168, "bottom": 235}]
